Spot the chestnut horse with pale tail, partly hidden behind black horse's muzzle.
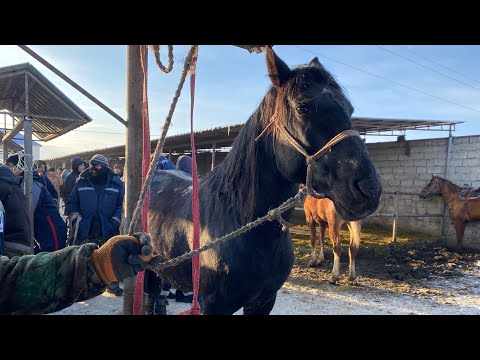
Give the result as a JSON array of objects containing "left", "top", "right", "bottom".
[{"left": 303, "top": 195, "right": 362, "bottom": 284}]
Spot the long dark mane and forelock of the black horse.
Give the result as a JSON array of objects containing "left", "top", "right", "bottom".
[{"left": 202, "top": 65, "right": 345, "bottom": 223}]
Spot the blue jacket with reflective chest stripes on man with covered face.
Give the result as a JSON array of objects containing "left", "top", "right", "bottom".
[{"left": 66, "top": 169, "right": 125, "bottom": 242}]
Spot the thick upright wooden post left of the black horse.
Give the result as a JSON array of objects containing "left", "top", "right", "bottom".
[{"left": 123, "top": 45, "right": 143, "bottom": 315}]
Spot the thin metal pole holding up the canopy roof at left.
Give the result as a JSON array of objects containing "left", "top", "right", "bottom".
[{"left": 23, "top": 73, "right": 35, "bottom": 254}]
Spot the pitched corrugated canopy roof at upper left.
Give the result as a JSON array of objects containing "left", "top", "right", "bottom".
[{"left": 0, "top": 63, "right": 92, "bottom": 141}]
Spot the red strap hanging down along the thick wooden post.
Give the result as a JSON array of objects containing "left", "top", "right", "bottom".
[{"left": 133, "top": 45, "right": 150, "bottom": 315}]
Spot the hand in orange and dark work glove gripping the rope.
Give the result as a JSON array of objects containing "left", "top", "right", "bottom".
[{"left": 92, "top": 233, "right": 163, "bottom": 284}]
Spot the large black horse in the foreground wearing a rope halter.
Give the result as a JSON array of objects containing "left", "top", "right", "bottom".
[{"left": 147, "top": 47, "right": 382, "bottom": 314}]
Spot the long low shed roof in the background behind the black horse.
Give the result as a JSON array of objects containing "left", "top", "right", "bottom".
[{"left": 50, "top": 117, "right": 462, "bottom": 161}]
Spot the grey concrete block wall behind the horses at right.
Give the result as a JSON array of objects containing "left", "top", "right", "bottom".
[{"left": 367, "top": 135, "right": 480, "bottom": 248}]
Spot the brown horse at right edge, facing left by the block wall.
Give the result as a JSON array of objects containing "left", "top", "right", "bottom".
[{"left": 420, "top": 175, "right": 480, "bottom": 249}]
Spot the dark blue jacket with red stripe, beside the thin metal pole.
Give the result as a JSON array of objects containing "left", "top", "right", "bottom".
[{"left": 21, "top": 171, "right": 67, "bottom": 253}]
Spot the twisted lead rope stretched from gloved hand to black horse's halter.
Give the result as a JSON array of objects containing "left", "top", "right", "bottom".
[{"left": 146, "top": 189, "right": 306, "bottom": 271}]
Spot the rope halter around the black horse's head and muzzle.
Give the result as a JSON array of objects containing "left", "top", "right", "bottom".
[{"left": 255, "top": 112, "right": 360, "bottom": 199}]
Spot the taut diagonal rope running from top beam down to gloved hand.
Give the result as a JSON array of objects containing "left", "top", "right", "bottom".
[{"left": 128, "top": 45, "right": 197, "bottom": 235}]
